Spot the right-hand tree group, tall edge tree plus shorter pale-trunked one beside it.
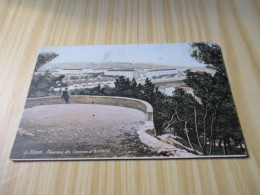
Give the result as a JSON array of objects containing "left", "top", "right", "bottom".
[{"left": 161, "top": 43, "right": 243, "bottom": 155}]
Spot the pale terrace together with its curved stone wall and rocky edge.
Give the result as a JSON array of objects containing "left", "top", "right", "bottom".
[{"left": 11, "top": 96, "right": 195, "bottom": 159}]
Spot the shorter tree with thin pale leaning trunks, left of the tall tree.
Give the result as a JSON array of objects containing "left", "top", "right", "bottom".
[{"left": 158, "top": 88, "right": 203, "bottom": 154}]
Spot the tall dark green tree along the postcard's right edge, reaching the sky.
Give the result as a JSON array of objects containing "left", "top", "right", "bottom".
[{"left": 187, "top": 43, "right": 242, "bottom": 154}]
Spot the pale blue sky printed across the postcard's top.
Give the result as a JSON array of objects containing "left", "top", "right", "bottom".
[{"left": 40, "top": 43, "right": 205, "bottom": 67}]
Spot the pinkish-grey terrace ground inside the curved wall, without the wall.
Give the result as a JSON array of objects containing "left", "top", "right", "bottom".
[{"left": 12, "top": 104, "right": 157, "bottom": 159}]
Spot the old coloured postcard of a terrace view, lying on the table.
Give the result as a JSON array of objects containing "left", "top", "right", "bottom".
[{"left": 10, "top": 43, "right": 247, "bottom": 161}]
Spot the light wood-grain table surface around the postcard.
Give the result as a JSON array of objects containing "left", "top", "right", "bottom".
[{"left": 0, "top": 0, "right": 260, "bottom": 195}]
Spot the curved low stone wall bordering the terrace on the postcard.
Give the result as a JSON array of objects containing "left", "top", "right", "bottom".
[{"left": 25, "top": 95, "right": 153, "bottom": 121}]
